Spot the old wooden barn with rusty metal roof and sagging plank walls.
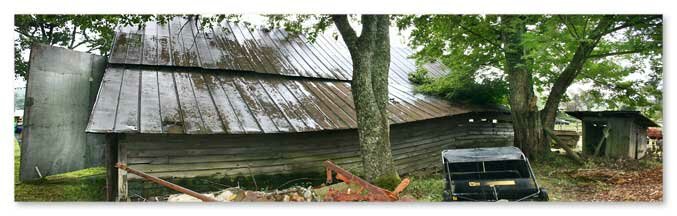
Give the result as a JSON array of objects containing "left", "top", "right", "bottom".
[{"left": 80, "top": 18, "right": 513, "bottom": 199}]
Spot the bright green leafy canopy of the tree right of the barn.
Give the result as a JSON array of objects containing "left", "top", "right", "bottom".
[{"left": 397, "top": 15, "right": 662, "bottom": 120}]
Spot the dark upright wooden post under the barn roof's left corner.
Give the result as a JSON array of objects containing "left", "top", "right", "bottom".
[{"left": 104, "top": 134, "right": 118, "bottom": 201}]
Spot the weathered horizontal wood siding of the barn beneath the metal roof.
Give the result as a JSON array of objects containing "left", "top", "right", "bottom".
[{"left": 119, "top": 117, "right": 513, "bottom": 179}]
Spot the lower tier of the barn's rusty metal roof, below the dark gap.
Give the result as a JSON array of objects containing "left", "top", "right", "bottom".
[{"left": 87, "top": 66, "right": 478, "bottom": 134}]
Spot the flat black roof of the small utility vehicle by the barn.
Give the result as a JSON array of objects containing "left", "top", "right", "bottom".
[{"left": 442, "top": 146, "right": 525, "bottom": 163}]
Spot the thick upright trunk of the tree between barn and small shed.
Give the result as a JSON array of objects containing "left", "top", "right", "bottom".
[{"left": 501, "top": 16, "right": 550, "bottom": 158}]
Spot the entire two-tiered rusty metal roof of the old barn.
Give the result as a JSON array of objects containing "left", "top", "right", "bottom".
[{"left": 87, "top": 19, "right": 491, "bottom": 134}]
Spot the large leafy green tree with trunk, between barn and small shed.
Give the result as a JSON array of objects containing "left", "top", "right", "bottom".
[{"left": 398, "top": 15, "right": 662, "bottom": 156}]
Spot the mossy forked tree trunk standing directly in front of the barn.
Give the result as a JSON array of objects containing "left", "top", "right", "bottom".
[{"left": 332, "top": 15, "right": 399, "bottom": 189}]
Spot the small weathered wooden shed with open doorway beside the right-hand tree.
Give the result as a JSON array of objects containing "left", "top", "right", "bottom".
[{"left": 567, "top": 111, "right": 658, "bottom": 159}]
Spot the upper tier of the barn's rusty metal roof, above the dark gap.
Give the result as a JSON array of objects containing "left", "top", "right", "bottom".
[{"left": 109, "top": 17, "right": 448, "bottom": 82}]
